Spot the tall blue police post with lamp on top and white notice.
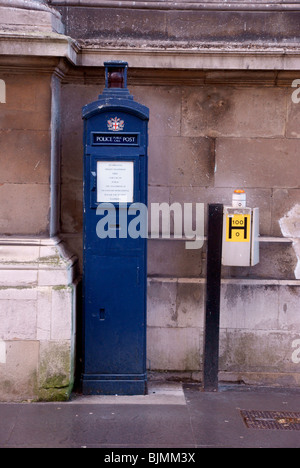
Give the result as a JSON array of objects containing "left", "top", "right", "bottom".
[{"left": 81, "top": 61, "right": 149, "bottom": 395}]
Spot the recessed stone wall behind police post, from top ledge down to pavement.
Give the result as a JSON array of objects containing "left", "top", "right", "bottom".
[{"left": 61, "top": 68, "right": 300, "bottom": 385}]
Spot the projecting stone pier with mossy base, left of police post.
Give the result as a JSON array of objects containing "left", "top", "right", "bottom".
[{"left": 0, "top": 0, "right": 77, "bottom": 401}]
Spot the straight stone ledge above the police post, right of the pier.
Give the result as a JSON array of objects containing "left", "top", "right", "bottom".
[{"left": 77, "top": 43, "right": 300, "bottom": 71}]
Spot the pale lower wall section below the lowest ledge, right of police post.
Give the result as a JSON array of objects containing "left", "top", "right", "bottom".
[{"left": 148, "top": 277, "right": 300, "bottom": 386}]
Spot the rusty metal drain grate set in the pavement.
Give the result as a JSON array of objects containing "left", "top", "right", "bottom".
[{"left": 240, "top": 410, "right": 300, "bottom": 431}]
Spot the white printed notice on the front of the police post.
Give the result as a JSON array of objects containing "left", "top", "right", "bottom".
[{"left": 97, "top": 161, "right": 134, "bottom": 203}]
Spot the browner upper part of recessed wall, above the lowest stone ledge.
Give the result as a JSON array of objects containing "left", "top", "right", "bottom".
[{"left": 62, "top": 69, "right": 300, "bottom": 272}]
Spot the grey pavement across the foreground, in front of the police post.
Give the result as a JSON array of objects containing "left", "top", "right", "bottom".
[{"left": 0, "top": 382, "right": 300, "bottom": 453}]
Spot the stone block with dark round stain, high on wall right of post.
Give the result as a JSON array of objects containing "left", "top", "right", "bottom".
[{"left": 182, "top": 86, "right": 286, "bottom": 138}]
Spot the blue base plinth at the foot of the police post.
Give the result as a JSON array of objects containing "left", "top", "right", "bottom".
[{"left": 81, "top": 374, "right": 147, "bottom": 395}]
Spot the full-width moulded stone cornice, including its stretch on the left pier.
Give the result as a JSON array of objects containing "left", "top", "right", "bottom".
[{"left": 0, "top": 29, "right": 300, "bottom": 71}]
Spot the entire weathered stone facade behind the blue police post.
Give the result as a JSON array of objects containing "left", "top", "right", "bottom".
[{"left": 0, "top": 0, "right": 300, "bottom": 400}]
